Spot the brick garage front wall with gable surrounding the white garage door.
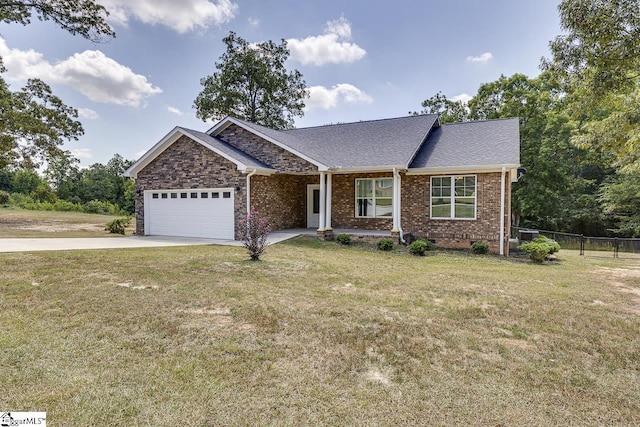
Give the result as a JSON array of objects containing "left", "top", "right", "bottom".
[{"left": 135, "top": 136, "right": 246, "bottom": 239}]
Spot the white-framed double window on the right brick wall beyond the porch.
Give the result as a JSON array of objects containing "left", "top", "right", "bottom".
[{"left": 431, "top": 175, "right": 477, "bottom": 219}]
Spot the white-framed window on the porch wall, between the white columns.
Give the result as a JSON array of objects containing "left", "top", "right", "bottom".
[{"left": 356, "top": 178, "right": 393, "bottom": 218}]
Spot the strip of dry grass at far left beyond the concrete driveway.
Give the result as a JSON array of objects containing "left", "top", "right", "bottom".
[{"left": 0, "top": 207, "right": 134, "bottom": 239}]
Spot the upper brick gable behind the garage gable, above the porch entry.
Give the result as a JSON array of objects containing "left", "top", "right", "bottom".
[{"left": 217, "top": 124, "right": 318, "bottom": 173}]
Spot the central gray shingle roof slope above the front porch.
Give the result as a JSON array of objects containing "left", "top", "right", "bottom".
[{"left": 231, "top": 114, "right": 438, "bottom": 169}]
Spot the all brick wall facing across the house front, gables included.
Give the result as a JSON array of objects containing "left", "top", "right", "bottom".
[{"left": 135, "top": 126, "right": 511, "bottom": 253}]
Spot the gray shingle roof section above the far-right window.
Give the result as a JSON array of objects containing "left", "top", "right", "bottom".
[{"left": 410, "top": 118, "right": 520, "bottom": 169}]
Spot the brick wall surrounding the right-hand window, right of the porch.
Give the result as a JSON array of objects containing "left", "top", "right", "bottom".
[{"left": 402, "top": 173, "right": 511, "bottom": 253}]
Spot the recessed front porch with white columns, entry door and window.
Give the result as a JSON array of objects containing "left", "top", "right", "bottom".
[{"left": 246, "top": 172, "right": 401, "bottom": 239}]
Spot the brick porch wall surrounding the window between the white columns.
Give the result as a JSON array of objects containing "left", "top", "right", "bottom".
[{"left": 331, "top": 172, "right": 393, "bottom": 231}]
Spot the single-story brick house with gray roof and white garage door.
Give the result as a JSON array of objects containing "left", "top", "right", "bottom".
[{"left": 126, "top": 114, "right": 520, "bottom": 255}]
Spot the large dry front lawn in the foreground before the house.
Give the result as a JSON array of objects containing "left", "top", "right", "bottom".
[{"left": 0, "top": 238, "right": 640, "bottom": 426}]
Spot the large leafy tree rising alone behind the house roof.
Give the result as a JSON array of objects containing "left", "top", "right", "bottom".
[{"left": 194, "top": 31, "right": 308, "bottom": 129}]
